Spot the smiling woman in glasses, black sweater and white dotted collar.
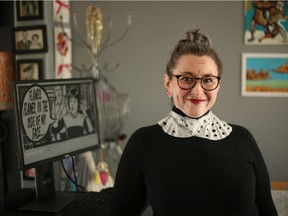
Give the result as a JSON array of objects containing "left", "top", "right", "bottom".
[{"left": 107, "top": 27, "right": 277, "bottom": 216}]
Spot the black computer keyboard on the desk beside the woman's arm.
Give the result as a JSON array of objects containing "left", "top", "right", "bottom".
[{"left": 54, "top": 188, "right": 112, "bottom": 216}]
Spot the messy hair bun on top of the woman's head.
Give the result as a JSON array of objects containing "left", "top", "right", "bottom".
[{"left": 185, "top": 26, "right": 212, "bottom": 47}]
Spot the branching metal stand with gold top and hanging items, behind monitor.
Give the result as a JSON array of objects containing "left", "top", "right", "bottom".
[{"left": 60, "top": 5, "right": 131, "bottom": 191}]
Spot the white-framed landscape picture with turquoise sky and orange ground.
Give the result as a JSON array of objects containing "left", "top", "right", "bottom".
[{"left": 242, "top": 53, "right": 288, "bottom": 97}]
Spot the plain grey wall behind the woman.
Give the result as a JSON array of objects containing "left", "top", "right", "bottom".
[{"left": 72, "top": 1, "right": 288, "bottom": 181}]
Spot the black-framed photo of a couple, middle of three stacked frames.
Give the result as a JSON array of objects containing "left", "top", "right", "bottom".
[{"left": 14, "top": 25, "right": 48, "bottom": 54}]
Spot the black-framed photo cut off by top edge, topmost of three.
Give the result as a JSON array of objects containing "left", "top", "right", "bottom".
[{"left": 15, "top": 0, "right": 43, "bottom": 21}]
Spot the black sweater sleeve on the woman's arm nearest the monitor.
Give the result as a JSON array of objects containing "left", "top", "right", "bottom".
[{"left": 106, "top": 127, "right": 146, "bottom": 216}]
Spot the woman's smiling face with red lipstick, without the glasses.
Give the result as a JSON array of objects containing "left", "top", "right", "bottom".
[{"left": 164, "top": 54, "right": 220, "bottom": 118}]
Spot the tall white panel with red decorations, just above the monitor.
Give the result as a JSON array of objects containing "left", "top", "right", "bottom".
[{"left": 54, "top": 27, "right": 72, "bottom": 79}]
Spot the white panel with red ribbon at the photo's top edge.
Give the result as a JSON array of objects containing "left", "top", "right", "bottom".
[{"left": 53, "top": 0, "right": 70, "bottom": 24}]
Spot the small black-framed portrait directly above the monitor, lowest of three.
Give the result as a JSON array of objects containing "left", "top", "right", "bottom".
[{"left": 16, "top": 59, "right": 43, "bottom": 80}]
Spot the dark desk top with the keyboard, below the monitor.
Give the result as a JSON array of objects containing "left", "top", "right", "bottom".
[{"left": 0, "top": 188, "right": 112, "bottom": 216}]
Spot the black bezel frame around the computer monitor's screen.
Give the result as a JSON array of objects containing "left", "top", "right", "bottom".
[{"left": 12, "top": 78, "right": 100, "bottom": 171}]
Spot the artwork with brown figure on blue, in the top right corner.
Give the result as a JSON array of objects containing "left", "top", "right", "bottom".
[{"left": 244, "top": 0, "right": 288, "bottom": 45}]
